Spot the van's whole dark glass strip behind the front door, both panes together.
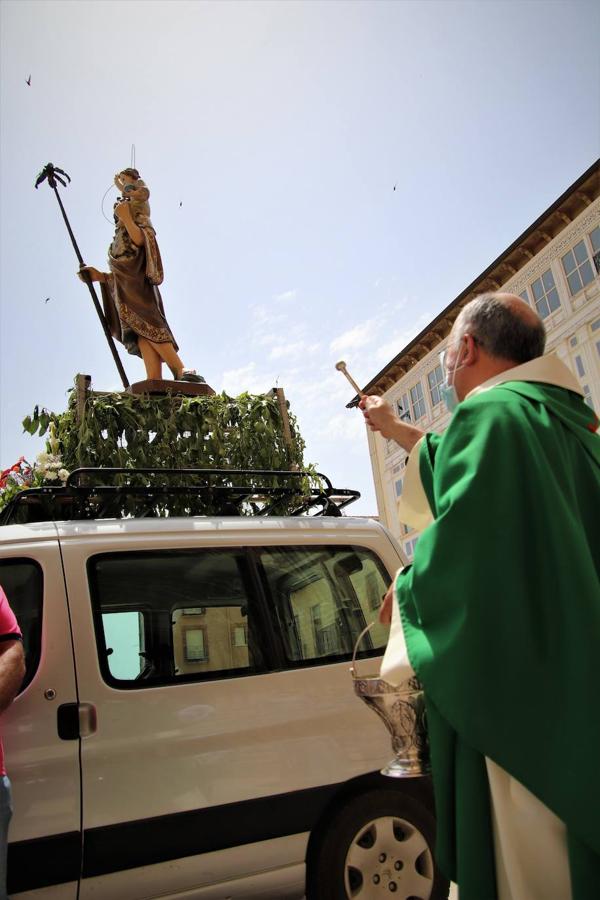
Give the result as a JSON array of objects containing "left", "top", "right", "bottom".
[{"left": 88, "top": 546, "right": 390, "bottom": 688}]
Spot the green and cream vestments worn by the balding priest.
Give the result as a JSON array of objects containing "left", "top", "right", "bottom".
[{"left": 386, "top": 357, "right": 600, "bottom": 900}]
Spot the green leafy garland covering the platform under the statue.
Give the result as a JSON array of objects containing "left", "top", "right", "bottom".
[{"left": 14, "top": 390, "right": 314, "bottom": 515}]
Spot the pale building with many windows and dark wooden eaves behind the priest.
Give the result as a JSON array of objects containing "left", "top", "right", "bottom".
[{"left": 349, "top": 160, "right": 600, "bottom": 559}]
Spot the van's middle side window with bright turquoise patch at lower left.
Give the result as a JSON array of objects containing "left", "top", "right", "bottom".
[{"left": 88, "top": 549, "right": 264, "bottom": 687}]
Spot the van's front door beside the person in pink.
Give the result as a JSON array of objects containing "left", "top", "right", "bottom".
[{"left": 0, "top": 526, "right": 81, "bottom": 900}]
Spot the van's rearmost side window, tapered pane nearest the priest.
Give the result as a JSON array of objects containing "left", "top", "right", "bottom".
[{"left": 260, "top": 546, "right": 390, "bottom": 665}]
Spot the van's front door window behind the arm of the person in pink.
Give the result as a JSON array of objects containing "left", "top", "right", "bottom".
[{"left": 0, "top": 559, "right": 44, "bottom": 691}]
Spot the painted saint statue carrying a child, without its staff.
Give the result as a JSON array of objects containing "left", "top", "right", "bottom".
[{"left": 80, "top": 169, "right": 204, "bottom": 382}]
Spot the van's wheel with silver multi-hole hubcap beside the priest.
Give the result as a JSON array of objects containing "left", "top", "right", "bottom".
[{"left": 307, "top": 788, "right": 450, "bottom": 900}]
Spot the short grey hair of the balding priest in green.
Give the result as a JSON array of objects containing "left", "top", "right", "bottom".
[{"left": 457, "top": 294, "right": 546, "bottom": 363}]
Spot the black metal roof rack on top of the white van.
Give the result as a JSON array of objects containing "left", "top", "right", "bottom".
[{"left": 0, "top": 468, "right": 360, "bottom": 525}]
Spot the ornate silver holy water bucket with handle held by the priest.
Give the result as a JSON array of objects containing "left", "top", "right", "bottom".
[{"left": 350, "top": 622, "right": 431, "bottom": 778}]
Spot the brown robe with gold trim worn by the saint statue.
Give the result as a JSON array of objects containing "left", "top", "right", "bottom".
[{"left": 101, "top": 219, "right": 179, "bottom": 356}]
